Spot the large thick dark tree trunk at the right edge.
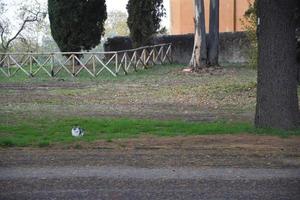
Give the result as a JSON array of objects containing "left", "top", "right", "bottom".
[{"left": 255, "top": 0, "right": 299, "bottom": 129}]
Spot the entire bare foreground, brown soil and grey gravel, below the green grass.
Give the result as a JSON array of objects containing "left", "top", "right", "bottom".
[{"left": 0, "top": 135, "right": 300, "bottom": 200}]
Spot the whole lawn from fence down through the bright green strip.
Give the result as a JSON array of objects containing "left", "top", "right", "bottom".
[{"left": 0, "top": 65, "right": 300, "bottom": 147}]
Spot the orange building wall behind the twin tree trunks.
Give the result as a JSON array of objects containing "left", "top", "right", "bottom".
[{"left": 170, "top": 0, "right": 249, "bottom": 34}]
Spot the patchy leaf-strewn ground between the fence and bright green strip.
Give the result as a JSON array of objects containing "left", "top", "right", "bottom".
[{"left": 0, "top": 66, "right": 256, "bottom": 121}]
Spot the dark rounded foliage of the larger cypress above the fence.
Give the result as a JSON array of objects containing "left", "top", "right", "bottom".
[{"left": 48, "top": 0, "right": 107, "bottom": 52}]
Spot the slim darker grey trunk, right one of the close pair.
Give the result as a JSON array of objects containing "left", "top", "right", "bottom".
[{"left": 208, "top": 0, "right": 220, "bottom": 66}]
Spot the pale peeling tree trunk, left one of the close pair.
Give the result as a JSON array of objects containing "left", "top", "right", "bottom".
[{"left": 190, "top": 0, "right": 207, "bottom": 70}]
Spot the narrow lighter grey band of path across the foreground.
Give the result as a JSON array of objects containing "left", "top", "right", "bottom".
[{"left": 0, "top": 166, "right": 300, "bottom": 180}]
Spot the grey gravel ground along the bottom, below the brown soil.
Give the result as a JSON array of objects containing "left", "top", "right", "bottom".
[{"left": 0, "top": 167, "right": 300, "bottom": 200}]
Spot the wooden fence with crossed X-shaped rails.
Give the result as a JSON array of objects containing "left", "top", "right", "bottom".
[{"left": 0, "top": 44, "right": 173, "bottom": 77}]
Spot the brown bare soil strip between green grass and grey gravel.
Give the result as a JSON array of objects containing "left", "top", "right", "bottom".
[{"left": 0, "top": 135, "right": 300, "bottom": 168}]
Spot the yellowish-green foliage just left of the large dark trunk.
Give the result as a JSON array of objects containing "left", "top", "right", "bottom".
[{"left": 242, "top": 0, "right": 258, "bottom": 69}]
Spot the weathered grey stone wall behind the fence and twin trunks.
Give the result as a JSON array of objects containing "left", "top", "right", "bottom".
[{"left": 104, "top": 32, "right": 249, "bottom": 64}]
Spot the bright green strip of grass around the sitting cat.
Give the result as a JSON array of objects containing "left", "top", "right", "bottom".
[{"left": 0, "top": 118, "right": 300, "bottom": 147}]
